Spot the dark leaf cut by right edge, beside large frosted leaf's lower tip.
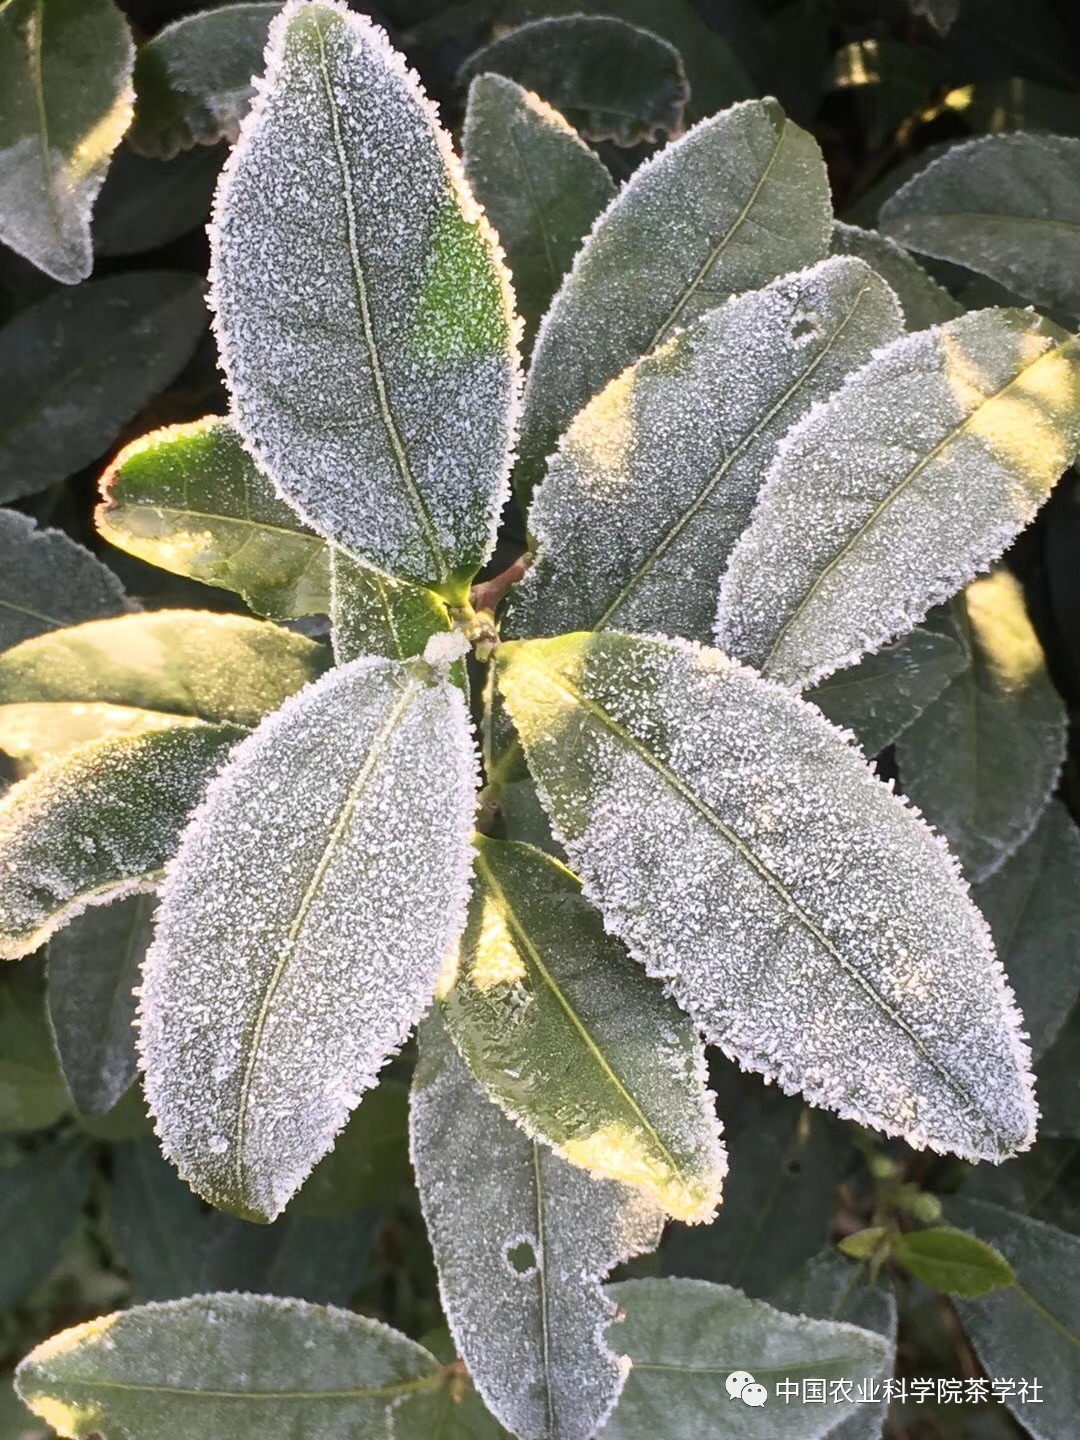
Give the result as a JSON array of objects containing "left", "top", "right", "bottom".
[{"left": 972, "top": 801, "right": 1080, "bottom": 1060}]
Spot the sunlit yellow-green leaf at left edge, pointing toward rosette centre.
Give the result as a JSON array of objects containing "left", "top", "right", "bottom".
[{"left": 0, "top": 611, "right": 328, "bottom": 726}]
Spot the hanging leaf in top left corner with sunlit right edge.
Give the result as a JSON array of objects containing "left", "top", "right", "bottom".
[{"left": 0, "top": 0, "right": 135, "bottom": 282}]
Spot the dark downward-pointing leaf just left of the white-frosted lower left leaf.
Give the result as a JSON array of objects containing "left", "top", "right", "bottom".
[{"left": 48, "top": 894, "right": 154, "bottom": 1115}]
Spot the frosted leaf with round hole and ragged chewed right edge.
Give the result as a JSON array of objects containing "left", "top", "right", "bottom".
[{"left": 410, "top": 1014, "right": 664, "bottom": 1440}]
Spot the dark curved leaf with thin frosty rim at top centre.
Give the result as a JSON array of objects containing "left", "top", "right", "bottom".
[{"left": 461, "top": 14, "right": 690, "bottom": 145}]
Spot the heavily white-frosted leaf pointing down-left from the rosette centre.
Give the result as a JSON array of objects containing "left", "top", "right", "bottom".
[{"left": 140, "top": 658, "right": 477, "bottom": 1220}]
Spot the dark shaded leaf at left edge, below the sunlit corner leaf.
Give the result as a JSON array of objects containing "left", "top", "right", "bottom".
[{"left": 0, "top": 273, "right": 206, "bottom": 503}]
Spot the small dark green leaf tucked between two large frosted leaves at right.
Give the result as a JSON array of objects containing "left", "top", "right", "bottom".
[{"left": 805, "top": 625, "right": 969, "bottom": 756}]
